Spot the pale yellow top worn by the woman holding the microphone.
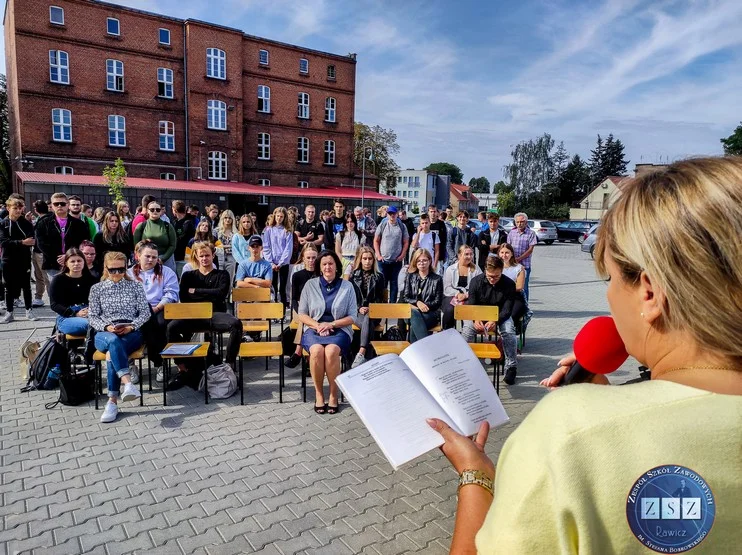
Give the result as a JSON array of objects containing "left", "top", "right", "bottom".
[{"left": 476, "top": 380, "right": 742, "bottom": 555}]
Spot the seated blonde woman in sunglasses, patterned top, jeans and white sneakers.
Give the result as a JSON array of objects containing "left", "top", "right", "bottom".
[{"left": 88, "top": 251, "right": 151, "bottom": 422}]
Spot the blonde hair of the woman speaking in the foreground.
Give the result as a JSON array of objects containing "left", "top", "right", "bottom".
[{"left": 595, "top": 157, "right": 742, "bottom": 364}]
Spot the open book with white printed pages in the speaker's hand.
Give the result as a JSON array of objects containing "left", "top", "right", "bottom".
[{"left": 337, "top": 329, "right": 509, "bottom": 470}]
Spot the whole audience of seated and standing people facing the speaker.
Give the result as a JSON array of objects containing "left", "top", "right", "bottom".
[{"left": 0, "top": 193, "right": 532, "bottom": 422}]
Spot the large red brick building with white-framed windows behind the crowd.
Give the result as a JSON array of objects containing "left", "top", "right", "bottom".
[{"left": 4, "top": 0, "right": 384, "bottom": 211}]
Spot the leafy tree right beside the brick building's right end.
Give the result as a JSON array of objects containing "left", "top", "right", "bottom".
[{"left": 353, "top": 121, "right": 399, "bottom": 194}]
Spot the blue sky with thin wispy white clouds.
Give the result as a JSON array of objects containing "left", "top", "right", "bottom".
[{"left": 0, "top": 0, "right": 742, "bottom": 187}]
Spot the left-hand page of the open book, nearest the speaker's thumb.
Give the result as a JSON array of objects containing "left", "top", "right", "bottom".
[{"left": 337, "top": 355, "right": 456, "bottom": 470}]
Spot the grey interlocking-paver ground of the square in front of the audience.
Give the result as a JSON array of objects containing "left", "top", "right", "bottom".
[{"left": 0, "top": 243, "right": 636, "bottom": 555}]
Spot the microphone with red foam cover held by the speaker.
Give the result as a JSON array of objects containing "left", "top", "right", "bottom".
[{"left": 562, "top": 316, "right": 629, "bottom": 385}]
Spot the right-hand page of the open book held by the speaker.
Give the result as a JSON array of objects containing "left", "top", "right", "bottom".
[{"left": 400, "top": 329, "right": 509, "bottom": 435}]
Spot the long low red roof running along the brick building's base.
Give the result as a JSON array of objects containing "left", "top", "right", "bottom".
[{"left": 16, "top": 172, "right": 398, "bottom": 201}]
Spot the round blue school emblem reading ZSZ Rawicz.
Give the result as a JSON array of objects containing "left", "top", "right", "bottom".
[{"left": 626, "top": 464, "right": 716, "bottom": 553}]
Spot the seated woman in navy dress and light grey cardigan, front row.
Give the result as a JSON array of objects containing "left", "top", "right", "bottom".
[{"left": 297, "top": 251, "right": 358, "bottom": 414}]
